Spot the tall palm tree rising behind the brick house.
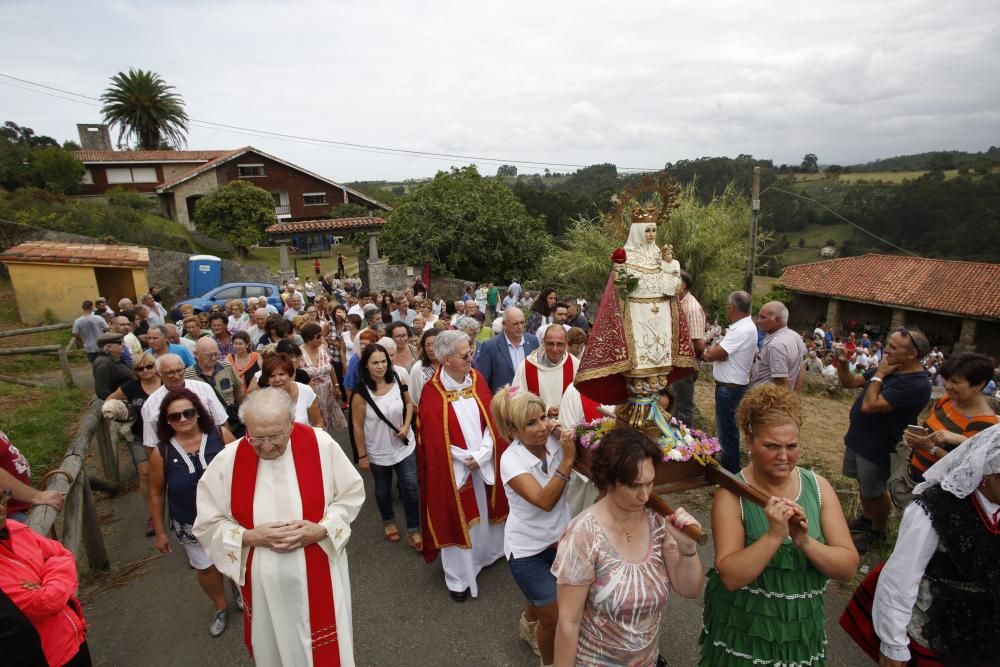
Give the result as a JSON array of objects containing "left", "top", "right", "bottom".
[{"left": 101, "top": 68, "right": 188, "bottom": 150}]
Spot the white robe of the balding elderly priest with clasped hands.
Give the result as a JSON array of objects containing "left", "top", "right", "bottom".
[{"left": 194, "top": 429, "right": 365, "bottom": 667}]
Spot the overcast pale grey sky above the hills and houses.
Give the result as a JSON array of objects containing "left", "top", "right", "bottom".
[{"left": 0, "top": 0, "right": 1000, "bottom": 181}]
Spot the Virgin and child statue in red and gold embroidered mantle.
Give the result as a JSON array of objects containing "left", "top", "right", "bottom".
[{"left": 575, "top": 211, "right": 696, "bottom": 423}]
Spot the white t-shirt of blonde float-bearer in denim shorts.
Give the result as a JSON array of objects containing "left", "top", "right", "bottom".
[{"left": 500, "top": 437, "right": 569, "bottom": 559}]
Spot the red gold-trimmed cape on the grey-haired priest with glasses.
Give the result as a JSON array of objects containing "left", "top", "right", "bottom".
[{"left": 416, "top": 369, "right": 508, "bottom": 563}]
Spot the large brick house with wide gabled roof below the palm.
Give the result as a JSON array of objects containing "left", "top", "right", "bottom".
[{"left": 74, "top": 138, "right": 389, "bottom": 229}]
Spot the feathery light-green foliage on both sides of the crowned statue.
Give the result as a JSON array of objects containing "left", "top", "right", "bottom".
[{"left": 542, "top": 183, "right": 752, "bottom": 314}]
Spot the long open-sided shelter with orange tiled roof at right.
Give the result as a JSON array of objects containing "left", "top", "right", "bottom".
[{"left": 781, "top": 254, "right": 1000, "bottom": 355}]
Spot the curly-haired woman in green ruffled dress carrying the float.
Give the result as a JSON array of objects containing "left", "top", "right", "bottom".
[{"left": 699, "top": 384, "right": 858, "bottom": 667}]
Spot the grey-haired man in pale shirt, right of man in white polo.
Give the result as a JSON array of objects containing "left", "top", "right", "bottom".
[{"left": 750, "top": 301, "right": 806, "bottom": 391}]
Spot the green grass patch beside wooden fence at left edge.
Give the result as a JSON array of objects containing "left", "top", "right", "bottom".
[{"left": 0, "top": 383, "right": 92, "bottom": 486}]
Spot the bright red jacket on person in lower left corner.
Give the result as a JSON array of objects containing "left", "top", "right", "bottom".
[{"left": 0, "top": 519, "right": 86, "bottom": 665}]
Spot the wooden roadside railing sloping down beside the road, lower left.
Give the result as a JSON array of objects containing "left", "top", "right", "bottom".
[{"left": 28, "top": 399, "right": 117, "bottom": 570}]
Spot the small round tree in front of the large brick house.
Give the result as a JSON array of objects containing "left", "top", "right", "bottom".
[{"left": 194, "top": 181, "right": 277, "bottom": 255}]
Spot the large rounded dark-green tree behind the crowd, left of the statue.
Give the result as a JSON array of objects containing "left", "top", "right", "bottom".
[{"left": 379, "top": 166, "right": 551, "bottom": 282}]
